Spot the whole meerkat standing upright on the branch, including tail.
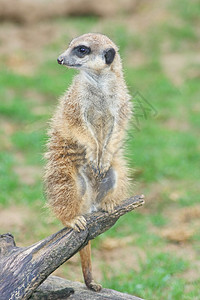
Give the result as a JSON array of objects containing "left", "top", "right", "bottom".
[{"left": 44, "top": 33, "right": 131, "bottom": 291}]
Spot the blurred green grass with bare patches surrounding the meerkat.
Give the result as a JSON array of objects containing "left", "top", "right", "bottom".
[{"left": 0, "top": 1, "right": 200, "bottom": 300}]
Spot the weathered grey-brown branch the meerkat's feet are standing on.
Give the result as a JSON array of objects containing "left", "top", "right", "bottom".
[{"left": 0, "top": 196, "right": 144, "bottom": 300}]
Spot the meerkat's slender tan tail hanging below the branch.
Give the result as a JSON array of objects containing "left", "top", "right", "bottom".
[{"left": 79, "top": 241, "right": 102, "bottom": 292}]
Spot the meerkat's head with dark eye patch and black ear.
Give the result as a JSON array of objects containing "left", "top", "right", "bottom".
[{"left": 57, "top": 33, "right": 119, "bottom": 74}]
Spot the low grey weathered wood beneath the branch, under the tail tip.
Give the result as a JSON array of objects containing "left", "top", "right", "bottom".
[{"left": 29, "top": 276, "right": 141, "bottom": 300}]
